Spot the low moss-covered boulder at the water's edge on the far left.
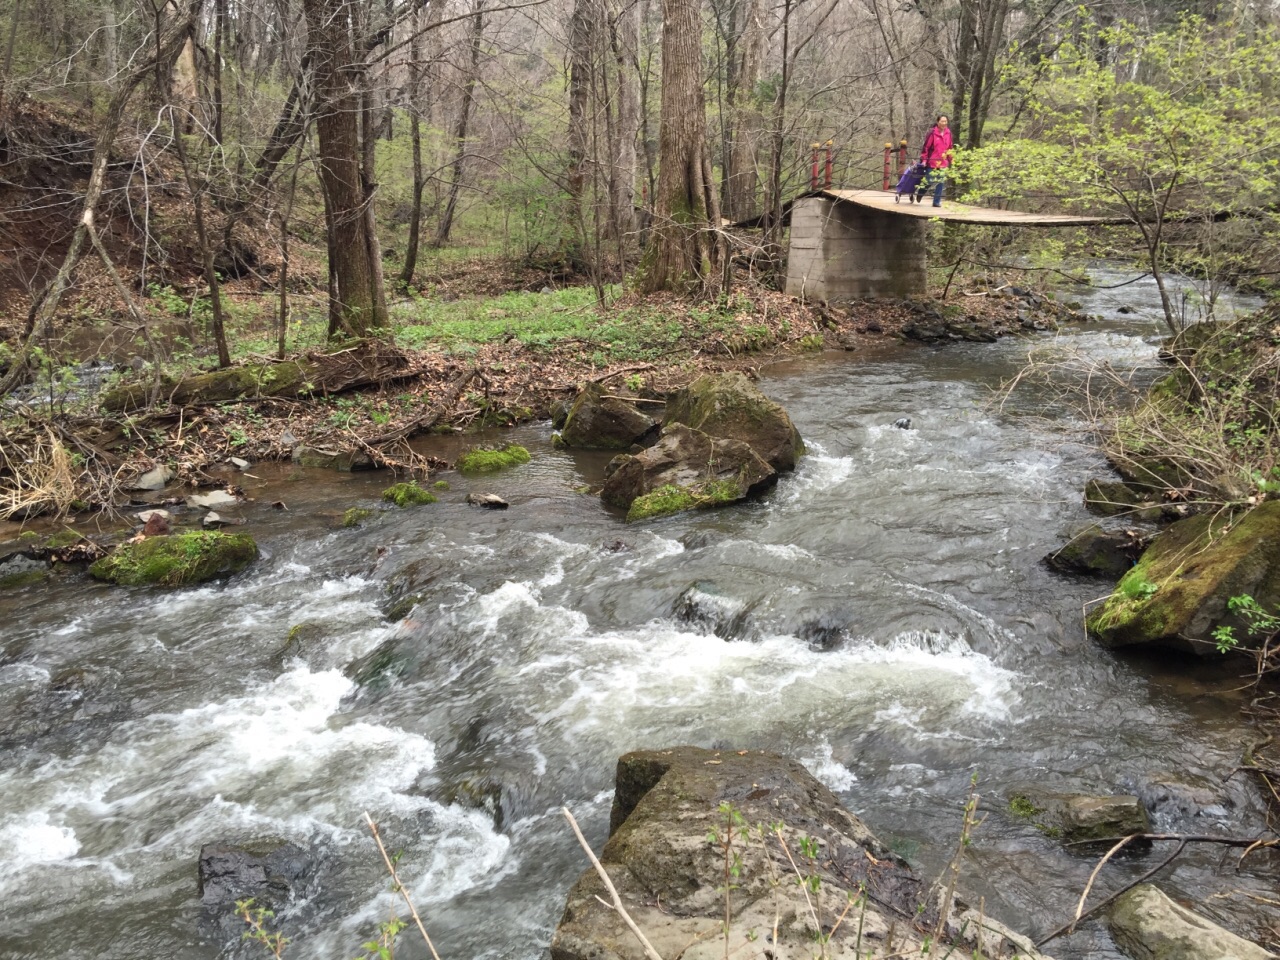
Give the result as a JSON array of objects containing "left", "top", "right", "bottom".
[{"left": 88, "top": 531, "right": 257, "bottom": 586}]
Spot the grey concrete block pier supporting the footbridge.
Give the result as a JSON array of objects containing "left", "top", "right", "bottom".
[{"left": 786, "top": 195, "right": 928, "bottom": 301}]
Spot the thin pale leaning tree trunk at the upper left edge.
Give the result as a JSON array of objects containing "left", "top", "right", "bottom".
[{"left": 0, "top": 0, "right": 201, "bottom": 394}]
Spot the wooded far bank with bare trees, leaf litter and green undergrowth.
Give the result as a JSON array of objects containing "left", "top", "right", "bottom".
[{"left": 0, "top": 0, "right": 1280, "bottom": 512}]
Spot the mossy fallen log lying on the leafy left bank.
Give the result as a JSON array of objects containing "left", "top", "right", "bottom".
[{"left": 99, "top": 340, "right": 415, "bottom": 412}]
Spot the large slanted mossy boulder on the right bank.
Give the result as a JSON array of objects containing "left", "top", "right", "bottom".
[{"left": 1087, "top": 500, "right": 1280, "bottom": 655}]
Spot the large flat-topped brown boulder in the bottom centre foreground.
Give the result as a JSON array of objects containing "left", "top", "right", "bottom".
[{"left": 550, "top": 746, "right": 1041, "bottom": 960}]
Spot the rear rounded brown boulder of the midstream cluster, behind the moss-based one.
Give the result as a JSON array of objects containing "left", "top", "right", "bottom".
[{"left": 662, "top": 372, "right": 804, "bottom": 474}]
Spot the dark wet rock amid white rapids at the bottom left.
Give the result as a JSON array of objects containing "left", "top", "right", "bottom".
[{"left": 196, "top": 840, "right": 316, "bottom": 908}]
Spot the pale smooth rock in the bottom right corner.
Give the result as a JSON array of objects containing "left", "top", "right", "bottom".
[{"left": 1107, "top": 883, "right": 1276, "bottom": 960}]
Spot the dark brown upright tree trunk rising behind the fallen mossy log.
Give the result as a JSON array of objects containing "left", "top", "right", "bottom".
[{"left": 302, "top": 0, "right": 387, "bottom": 337}]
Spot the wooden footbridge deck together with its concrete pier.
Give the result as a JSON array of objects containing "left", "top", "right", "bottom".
[{"left": 786, "top": 189, "right": 1126, "bottom": 301}]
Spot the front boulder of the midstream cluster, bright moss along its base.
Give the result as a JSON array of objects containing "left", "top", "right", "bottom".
[{"left": 600, "top": 424, "right": 777, "bottom": 520}]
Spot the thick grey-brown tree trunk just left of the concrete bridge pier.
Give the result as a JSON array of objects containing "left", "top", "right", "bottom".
[{"left": 639, "top": 0, "right": 724, "bottom": 294}]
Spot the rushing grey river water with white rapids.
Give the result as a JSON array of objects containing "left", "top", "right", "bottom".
[{"left": 0, "top": 264, "right": 1275, "bottom": 960}]
